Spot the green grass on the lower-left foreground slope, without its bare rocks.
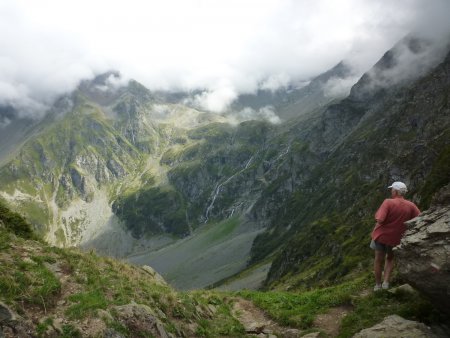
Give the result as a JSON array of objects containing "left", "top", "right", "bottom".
[{"left": 0, "top": 221, "right": 245, "bottom": 337}]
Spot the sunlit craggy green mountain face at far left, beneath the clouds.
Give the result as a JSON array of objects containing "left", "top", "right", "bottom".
[{"left": 0, "top": 94, "right": 142, "bottom": 244}]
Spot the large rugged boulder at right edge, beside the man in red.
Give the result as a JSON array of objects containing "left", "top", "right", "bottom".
[{"left": 395, "top": 189, "right": 450, "bottom": 316}]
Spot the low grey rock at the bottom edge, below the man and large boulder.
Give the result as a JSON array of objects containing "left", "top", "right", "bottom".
[{"left": 353, "top": 315, "right": 437, "bottom": 338}]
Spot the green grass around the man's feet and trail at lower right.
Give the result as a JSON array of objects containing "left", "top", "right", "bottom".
[{"left": 238, "top": 274, "right": 443, "bottom": 338}]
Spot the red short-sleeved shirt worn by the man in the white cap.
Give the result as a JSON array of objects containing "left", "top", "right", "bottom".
[{"left": 372, "top": 197, "right": 420, "bottom": 246}]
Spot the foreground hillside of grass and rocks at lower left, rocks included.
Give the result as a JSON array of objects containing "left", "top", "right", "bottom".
[{"left": 0, "top": 205, "right": 250, "bottom": 337}]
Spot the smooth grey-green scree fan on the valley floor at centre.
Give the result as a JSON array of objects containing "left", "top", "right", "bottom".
[{"left": 126, "top": 217, "right": 267, "bottom": 290}]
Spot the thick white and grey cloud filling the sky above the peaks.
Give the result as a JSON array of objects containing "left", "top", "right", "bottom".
[{"left": 0, "top": 0, "right": 450, "bottom": 116}]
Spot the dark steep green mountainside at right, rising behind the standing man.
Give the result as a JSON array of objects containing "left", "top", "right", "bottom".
[{"left": 252, "top": 43, "right": 450, "bottom": 287}]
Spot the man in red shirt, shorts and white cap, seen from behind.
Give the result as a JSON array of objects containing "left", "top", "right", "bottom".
[{"left": 370, "top": 182, "right": 420, "bottom": 291}]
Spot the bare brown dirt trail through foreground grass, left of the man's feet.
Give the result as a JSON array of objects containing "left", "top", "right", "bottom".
[{"left": 233, "top": 298, "right": 352, "bottom": 338}]
